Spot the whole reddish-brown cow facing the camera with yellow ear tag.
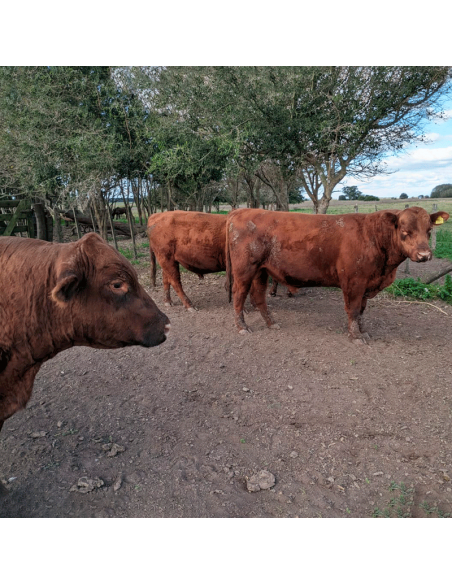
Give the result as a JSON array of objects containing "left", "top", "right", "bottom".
[{"left": 226, "top": 207, "right": 449, "bottom": 342}]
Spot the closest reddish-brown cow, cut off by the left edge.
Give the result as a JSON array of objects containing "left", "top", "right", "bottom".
[{"left": 0, "top": 233, "right": 170, "bottom": 429}]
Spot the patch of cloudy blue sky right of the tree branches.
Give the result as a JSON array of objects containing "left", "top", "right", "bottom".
[{"left": 340, "top": 99, "right": 452, "bottom": 199}]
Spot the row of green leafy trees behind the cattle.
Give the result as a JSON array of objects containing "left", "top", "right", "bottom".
[{"left": 0, "top": 66, "right": 451, "bottom": 242}]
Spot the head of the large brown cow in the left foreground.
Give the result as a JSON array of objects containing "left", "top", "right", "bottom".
[{"left": 50, "top": 233, "right": 171, "bottom": 349}]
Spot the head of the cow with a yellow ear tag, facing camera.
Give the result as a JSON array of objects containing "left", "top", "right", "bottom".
[{"left": 386, "top": 207, "right": 449, "bottom": 262}]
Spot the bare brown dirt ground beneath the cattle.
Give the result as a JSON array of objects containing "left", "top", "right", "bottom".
[{"left": 0, "top": 240, "right": 452, "bottom": 518}]
